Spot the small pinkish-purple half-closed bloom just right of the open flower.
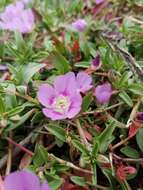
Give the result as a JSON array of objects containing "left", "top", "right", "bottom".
[{"left": 94, "top": 82, "right": 112, "bottom": 104}]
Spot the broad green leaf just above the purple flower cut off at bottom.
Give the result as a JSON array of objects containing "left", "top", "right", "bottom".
[{"left": 33, "top": 145, "right": 48, "bottom": 167}]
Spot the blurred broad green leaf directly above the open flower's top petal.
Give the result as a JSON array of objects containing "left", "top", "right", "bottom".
[{"left": 51, "top": 51, "right": 71, "bottom": 74}]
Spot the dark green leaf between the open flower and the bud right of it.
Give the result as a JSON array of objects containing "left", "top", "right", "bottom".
[{"left": 82, "top": 92, "right": 93, "bottom": 112}]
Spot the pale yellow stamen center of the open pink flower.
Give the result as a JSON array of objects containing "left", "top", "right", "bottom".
[{"left": 53, "top": 95, "right": 70, "bottom": 113}]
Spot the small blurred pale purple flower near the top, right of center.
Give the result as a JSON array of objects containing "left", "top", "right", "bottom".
[{"left": 72, "top": 19, "right": 87, "bottom": 32}]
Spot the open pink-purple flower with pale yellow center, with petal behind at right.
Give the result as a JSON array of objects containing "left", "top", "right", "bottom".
[{"left": 38, "top": 72, "right": 92, "bottom": 120}]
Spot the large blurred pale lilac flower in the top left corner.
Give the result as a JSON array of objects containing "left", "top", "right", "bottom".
[{"left": 0, "top": 2, "right": 34, "bottom": 33}]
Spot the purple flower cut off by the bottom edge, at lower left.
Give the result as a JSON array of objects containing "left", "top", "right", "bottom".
[{"left": 4, "top": 171, "right": 50, "bottom": 190}]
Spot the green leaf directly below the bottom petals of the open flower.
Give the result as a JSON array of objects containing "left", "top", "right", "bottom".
[{"left": 45, "top": 123, "right": 66, "bottom": 142}]
